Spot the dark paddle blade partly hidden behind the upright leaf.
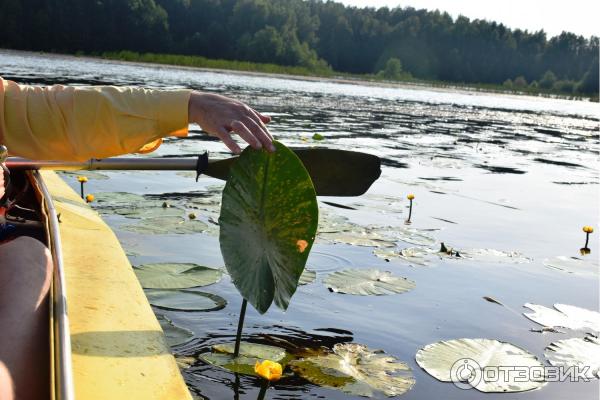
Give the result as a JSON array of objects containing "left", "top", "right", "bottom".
[{"left": 204, "top": 148, "right": 381, "bottom": 196}]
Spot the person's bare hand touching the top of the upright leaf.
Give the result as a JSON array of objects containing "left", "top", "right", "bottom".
[{"left": 188, "top": 91, "right": 275, "bottom": 154}]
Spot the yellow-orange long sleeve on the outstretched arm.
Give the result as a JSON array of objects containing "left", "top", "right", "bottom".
[{"left": 0, "top": 78, "right": 191, "bottom": 161}]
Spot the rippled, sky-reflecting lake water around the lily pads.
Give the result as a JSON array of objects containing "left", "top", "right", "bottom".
[{"left": 0, "top": 51, "right": 600, "bottom": 400}]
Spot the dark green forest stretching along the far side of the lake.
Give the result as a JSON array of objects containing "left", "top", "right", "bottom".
[{"left": 0, "top": 0, "right": 599, "bottom": 96}]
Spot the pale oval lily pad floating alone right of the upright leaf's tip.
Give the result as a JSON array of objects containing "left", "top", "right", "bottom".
[{"left": 323, "top": 269, "right": 415, "bottom": 296}]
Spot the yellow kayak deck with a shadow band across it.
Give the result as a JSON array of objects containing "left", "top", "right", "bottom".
[{"left": 41, "top": 171, "right": 191, "bottom": 400}]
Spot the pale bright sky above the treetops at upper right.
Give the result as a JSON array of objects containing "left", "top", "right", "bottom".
[{"left": 335, "top": 0, "right": 600, "bottom": 37}]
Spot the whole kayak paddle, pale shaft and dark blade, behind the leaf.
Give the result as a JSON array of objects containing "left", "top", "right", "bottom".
[{"left": 6, "top": 148, "right": 381, "bottom": 196}]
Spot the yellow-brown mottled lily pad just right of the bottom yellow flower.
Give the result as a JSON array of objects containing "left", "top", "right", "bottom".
[{"left": 290, "top": 343, "right": 415, "bottom": 397}]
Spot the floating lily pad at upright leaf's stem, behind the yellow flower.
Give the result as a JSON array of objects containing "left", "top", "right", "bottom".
[{"left": 198, "top": 342, "right": 291, "bottom": 376}]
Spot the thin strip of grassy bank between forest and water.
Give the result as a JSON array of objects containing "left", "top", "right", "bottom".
[{"left": 0, "top": 49, "right": 598, "bottom": 102}]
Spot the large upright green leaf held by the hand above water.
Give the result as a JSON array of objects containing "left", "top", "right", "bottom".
[{"left": 219, "top": 142, "right": 318, "bottom": 314}]
